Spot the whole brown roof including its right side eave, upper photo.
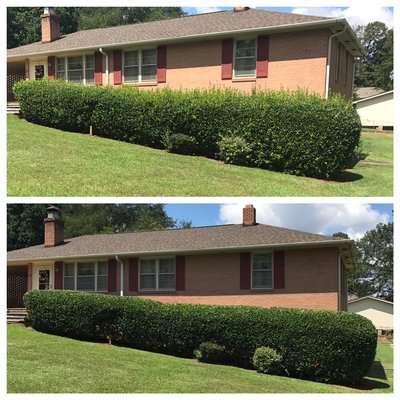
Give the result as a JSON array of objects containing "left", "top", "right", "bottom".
[{"left": 7, "top": 9, "right": 363, "bottom": 59}]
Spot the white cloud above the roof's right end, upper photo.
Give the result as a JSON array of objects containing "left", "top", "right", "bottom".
[{"left": 292, "top": 6, "right": 393, "bottom": 28}]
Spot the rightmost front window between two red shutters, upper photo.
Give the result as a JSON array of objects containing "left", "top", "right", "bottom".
[{"left": 234, "top": 39, "right": 256, "bottom": 78}]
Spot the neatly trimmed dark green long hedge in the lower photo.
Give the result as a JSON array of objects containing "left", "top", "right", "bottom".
[{"left": 25, "top": 291, "right": 377, "bottom": 384}]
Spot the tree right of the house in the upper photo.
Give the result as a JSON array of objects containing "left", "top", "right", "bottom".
[{"left": 354, "top": 21, "right": 393, "bottom": 90}]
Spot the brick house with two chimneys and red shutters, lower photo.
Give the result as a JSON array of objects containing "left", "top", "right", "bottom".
[{"left": 7, "top": 206, "right": 354, "bottom": 310}]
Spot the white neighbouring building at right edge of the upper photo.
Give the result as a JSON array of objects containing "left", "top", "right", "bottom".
[{"left": 353, "top": 90, "right": 394, "bottom": 129}]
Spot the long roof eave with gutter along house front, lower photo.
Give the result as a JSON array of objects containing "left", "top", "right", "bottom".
[{"left": 7, "top": 239, "right": 353, "bottom": 266}]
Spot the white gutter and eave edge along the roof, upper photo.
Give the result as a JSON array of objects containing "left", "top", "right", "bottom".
[{"left": 7, "top": 18, "right": 364, "bottom": 61}]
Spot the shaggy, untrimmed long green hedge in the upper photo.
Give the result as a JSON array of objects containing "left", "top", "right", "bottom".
[{"left": 14, "top": 81, "right": 361, "bottom": 178}]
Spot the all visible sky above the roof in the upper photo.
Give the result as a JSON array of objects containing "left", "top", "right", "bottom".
[{"left": 182, "top": 6, "right": 393, "bottom": 28}]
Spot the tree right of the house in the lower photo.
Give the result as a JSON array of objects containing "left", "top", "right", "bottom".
[{"left": 348, "top": 223, "right": 393, "bottom": 301}]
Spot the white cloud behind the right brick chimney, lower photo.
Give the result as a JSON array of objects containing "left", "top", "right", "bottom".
[{"left": 219, "top": 203, "right": 389, "bottom": 239}]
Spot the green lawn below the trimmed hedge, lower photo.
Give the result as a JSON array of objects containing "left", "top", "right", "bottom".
[{"left": 7, "top": 325, "right": 393, "bottom": 393}]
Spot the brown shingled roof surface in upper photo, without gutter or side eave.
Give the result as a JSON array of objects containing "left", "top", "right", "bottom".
[{"left": 7, "top": 9, "right": 331, "bottom": 56}]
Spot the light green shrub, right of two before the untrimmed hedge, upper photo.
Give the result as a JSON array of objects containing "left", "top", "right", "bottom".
[{"left": 218, "top": 136, "right": 251, "bottom": 165}]
